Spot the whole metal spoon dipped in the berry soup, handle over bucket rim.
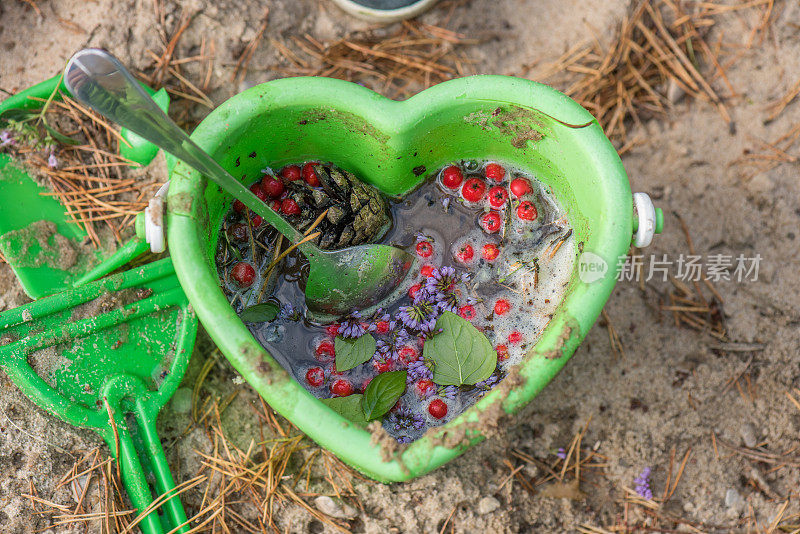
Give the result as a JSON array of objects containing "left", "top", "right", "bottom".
[{"left": 64, "top": 48, "right": 414, "bottom": 316}]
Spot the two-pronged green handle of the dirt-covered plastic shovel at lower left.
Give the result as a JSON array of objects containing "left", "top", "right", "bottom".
[{"left": 103, "top": 390, "right": 190, "bottom": 534}]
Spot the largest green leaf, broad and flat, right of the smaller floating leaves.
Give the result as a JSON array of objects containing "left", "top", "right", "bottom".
[{"left": 422, "top": 311, "right": 497, "bottom": 386}]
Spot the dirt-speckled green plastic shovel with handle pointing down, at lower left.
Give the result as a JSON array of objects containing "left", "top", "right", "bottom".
[{"left": 0, "top": 258, "right": 197, "bottom": 534}]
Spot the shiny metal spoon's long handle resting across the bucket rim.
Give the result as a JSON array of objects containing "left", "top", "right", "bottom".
[{"left": 64, "top": 48, "right": 310, "bottom": 251}]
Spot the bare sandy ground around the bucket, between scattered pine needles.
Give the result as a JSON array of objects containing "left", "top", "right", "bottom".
[{"left": 0, "top": 0, "right": 800, "bottom": 533}]
